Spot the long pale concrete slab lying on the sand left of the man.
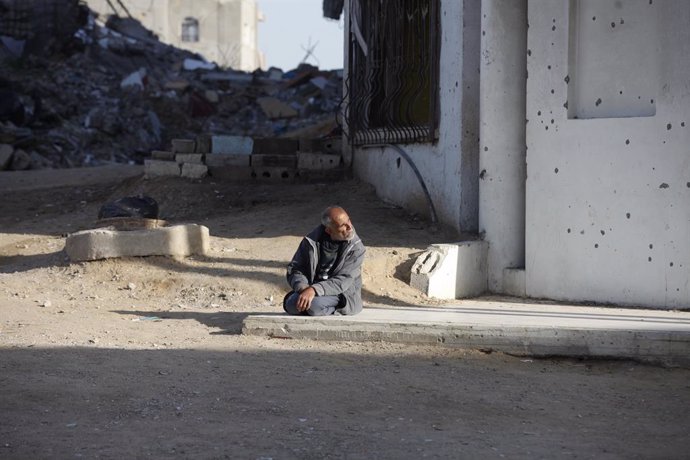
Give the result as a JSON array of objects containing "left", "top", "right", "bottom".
[{"left": 65, "top": 224, "right": 209, "bottom": 262}]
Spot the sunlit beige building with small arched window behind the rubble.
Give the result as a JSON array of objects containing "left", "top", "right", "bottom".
[{"left": 86, "top": 0, "right": 265, "bottom": 72}]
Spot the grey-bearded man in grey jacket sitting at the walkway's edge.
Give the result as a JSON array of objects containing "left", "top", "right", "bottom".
[{"left": 283, "top": 206, "right": 365, "bottom": 316}]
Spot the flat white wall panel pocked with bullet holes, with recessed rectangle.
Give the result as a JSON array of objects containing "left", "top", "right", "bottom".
[{"left": 525, "top": 0, "right": 690, "bottom": 308}]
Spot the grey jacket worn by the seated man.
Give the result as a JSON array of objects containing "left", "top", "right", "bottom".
[{"left": 287, "top": 225, "right": 365, "bottom": 315}]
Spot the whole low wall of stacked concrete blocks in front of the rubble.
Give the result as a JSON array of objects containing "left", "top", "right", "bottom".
[{"left": 145, "top": 135, "right": 343, "bottom": 182}]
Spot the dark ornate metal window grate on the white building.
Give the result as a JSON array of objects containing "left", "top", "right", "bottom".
[{"left": 343, "top": 0, "right": 440, "bottom": 145}]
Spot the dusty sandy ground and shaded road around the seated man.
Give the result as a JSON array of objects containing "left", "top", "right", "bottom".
[{"left": 0, "top": 167, "right": 690, "bottom": 459}]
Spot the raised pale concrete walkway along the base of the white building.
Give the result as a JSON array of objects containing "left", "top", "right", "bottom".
[{"left": 243, "top": 300, "right": 690, "bottom": 367}]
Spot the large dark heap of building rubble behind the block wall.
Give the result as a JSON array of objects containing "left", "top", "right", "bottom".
[{"left": 0, "top": 9, "right": 342, "bottom": 170}]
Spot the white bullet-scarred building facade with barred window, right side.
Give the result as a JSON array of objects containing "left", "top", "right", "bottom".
[{"left": 340, "top": 0, "right": 690, "bottom": 308}]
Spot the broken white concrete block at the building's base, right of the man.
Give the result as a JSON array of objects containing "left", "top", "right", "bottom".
[{"left": 410, "top": 241, "right": 488, "bottom": 299}]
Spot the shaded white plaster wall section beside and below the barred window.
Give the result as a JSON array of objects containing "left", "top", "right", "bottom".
[{"left": 353, "top": 0, "right": 479, "bottom": 232}]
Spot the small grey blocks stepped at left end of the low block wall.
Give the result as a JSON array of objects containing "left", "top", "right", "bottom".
[{"left": 144, "top": 139, "right": 208, "bottom": 179}]
